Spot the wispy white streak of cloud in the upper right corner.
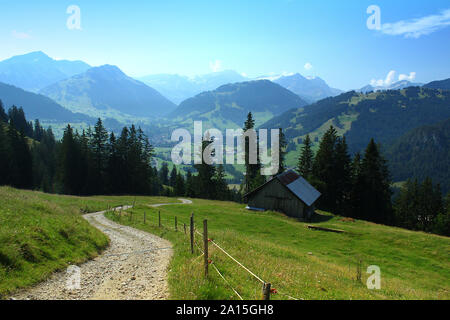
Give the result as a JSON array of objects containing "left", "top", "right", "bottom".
[{"left": 380, "top": 9, "right": 450, "bottom": 38}]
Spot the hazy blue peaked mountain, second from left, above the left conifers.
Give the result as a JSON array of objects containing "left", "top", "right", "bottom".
[{"left": 40, "top": 65, "right": 176, "bottom": 118}]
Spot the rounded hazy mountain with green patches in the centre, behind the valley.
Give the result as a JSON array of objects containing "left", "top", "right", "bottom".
[{"left": 169, "top": 80, "right": 308, "bottom": 129}]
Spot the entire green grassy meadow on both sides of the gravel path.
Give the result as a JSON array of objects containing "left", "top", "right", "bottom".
[{"left": 0, "top": 187, "right": 450, "bottom": 299}]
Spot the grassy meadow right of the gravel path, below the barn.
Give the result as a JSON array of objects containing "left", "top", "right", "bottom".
[{"left": 108, "top": 200, "right": 450, "bottom": 299}]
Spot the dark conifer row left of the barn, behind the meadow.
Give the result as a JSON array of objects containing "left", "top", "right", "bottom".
[{"left": 0, "top": 100, "right": 240, "bottom": 201}]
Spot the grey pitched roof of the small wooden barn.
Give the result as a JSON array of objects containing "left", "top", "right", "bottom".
[{"left": 244, "top": 170, "right": 321, "bottom": 207}]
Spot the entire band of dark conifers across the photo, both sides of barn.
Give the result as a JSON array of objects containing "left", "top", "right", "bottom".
[{"left": 0, "top": 100, "right": 450, "bottom": 235}]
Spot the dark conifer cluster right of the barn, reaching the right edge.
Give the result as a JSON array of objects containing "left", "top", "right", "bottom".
[{"left": 297, "top": 126, "right": 450, "bottom": 235}]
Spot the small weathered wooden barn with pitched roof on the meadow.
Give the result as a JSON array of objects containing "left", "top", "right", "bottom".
[{"left": 244, "top": 170, "right": 320, "bottom": 219}]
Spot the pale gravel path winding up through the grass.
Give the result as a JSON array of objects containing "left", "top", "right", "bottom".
[{"left": 11, "top": 199, "right": 192, "bottom": 300}]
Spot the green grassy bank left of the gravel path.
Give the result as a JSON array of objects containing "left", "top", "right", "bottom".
[{"left": 0, "top": 187, "right": 178, "bottom": 298}]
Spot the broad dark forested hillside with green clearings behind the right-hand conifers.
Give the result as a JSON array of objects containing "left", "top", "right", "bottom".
[{"left": 261, "top": 87, "right": 450, "bottom": 152}]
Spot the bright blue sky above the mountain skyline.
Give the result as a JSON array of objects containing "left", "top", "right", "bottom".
[{"left": 0, "top": 0, "right": 450, "bottom": 89}]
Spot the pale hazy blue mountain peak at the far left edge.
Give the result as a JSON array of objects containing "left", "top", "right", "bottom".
[{"left": 0, "top": 51, "right": 90, "bottom": 92}]
